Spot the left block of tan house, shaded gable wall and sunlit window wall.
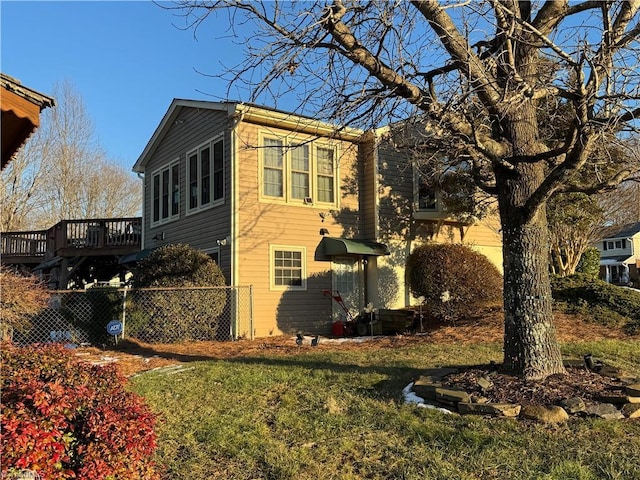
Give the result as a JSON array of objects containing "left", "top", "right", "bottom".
[{"left": 134, "top": 100, "right": 379, "bottom": 337}]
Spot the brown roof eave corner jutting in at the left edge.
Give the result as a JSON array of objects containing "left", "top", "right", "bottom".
[{"left": 0, "top": 73, "right": 55, "bottom": 168}]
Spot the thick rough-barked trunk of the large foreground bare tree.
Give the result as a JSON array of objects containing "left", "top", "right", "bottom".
[{"left": 495, "top": 108, "right": 565, "bottom": 379}]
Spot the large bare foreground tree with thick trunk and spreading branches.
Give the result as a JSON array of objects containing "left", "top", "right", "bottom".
[{"left": 176, "top": 0, "right": 640, "bottom": 379}]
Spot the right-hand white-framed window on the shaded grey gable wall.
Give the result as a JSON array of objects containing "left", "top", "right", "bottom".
[{"left": 187, "top": 138, "right": 224, "bottom": 212}]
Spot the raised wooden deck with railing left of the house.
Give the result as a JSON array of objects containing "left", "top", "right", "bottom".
[{"left": 0, "top": 217, "right": 142, "bottom": 266}]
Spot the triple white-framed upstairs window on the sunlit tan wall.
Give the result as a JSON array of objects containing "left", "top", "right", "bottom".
[{"left": 262, "top": 137, "right": 336, "bottom": 204}]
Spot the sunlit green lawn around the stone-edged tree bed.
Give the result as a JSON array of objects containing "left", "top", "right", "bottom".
[{"left": 132, "top": 341, "right": 640, "bottom": 480}]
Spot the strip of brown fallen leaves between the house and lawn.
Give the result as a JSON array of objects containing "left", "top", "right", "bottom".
[{"left": 78, "top": 310, "right": 640, "bottom": 376}]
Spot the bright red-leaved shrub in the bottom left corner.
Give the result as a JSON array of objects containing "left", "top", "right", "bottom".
[{"left": 0, "top": 344, "right": 159, "bottom": 480}]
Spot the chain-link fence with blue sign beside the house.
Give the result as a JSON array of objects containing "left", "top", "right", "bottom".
[{"left": 6, "top": 286, "right": 253, "bottom": 345}]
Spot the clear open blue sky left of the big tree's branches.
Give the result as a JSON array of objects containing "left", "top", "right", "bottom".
[{"left": 0, "top": 0, "right": 250, "bottom": 169}]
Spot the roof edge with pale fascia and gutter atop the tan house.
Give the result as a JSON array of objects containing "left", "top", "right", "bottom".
[{"left": 133, "top": 98, "right": 365, "bottom": 173}]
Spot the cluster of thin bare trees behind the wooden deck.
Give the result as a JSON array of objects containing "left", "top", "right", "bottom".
[{"left": 1, "top": 82, "right": 142, "bottom": 231}]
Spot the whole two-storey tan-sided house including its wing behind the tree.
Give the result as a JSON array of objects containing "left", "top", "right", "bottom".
[{"left": 134, "top": 99, "right": 500, "bottom": 337}]
